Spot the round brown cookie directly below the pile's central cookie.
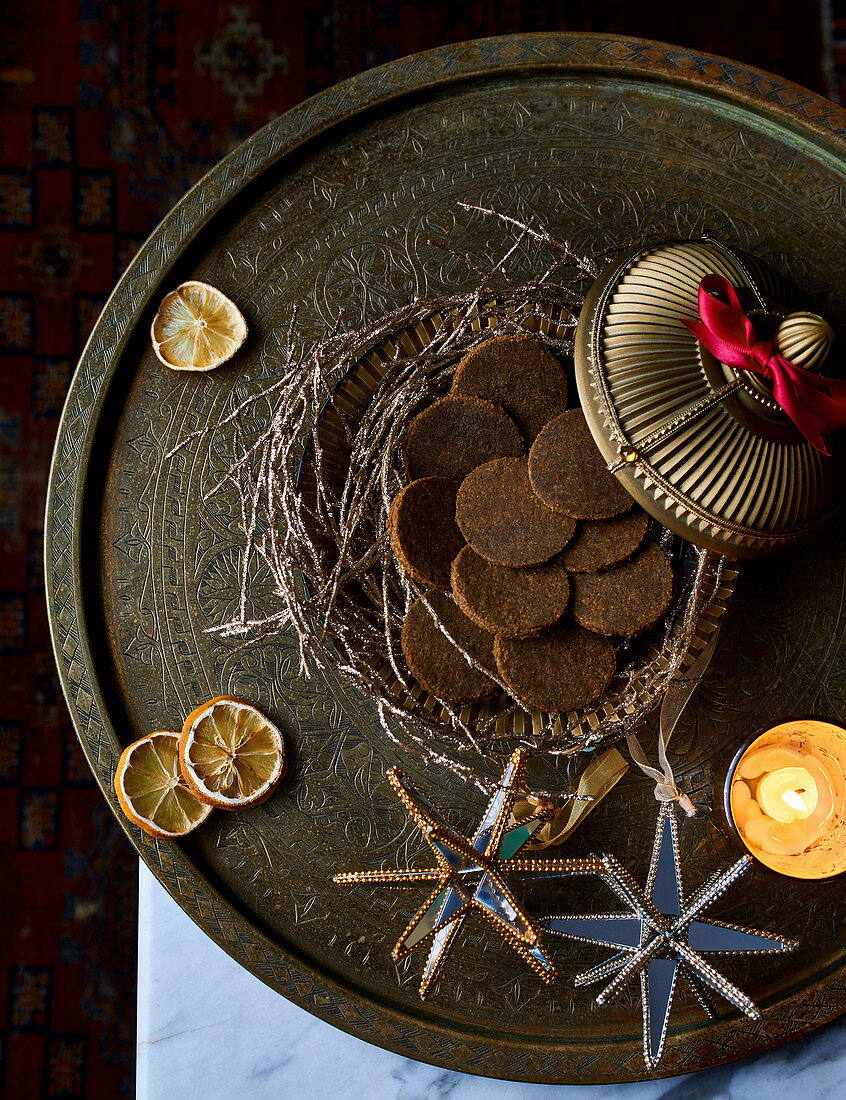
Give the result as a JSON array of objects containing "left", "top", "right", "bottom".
[{"left": 452, "top": 547, "right": 570, "bottom": 638}]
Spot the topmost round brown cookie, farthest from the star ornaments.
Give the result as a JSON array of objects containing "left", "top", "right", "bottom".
[{"left": 450, "top": 336, "right": 567, "bottom": 443}]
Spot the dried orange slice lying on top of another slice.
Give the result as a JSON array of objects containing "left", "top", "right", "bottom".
[{"left": 179, "top": 695, "right": 286, "bottom": 810}]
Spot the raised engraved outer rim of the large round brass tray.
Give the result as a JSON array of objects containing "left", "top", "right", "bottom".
[{"left": 44, "top": 33, "right": 846, "bottom": 1084}]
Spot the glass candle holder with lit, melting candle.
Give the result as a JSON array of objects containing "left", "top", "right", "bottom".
[{"left": 725, "top": 718, "right": 846, "bottom": 879}]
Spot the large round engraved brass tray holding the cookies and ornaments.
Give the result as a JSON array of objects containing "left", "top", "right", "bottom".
[{"left": 46, "top": 34, "right": 846, "bottom": 1082}]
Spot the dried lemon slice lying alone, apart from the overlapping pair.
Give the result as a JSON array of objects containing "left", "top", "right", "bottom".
[{"left": 150, "top": 281, "right": 246, "bottom": 371}]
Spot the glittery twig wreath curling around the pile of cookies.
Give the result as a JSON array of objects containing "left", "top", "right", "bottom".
[{"left": 180, "top": 208, "right": 732, "bottom": 798}]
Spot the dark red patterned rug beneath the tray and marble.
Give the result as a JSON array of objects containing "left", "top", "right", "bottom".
[{"left": 0, "top": 0, "right": 831, "bottom": 1098}]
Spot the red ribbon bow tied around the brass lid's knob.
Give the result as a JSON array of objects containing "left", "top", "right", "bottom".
[{"left": 680, "top": 275, "right": 846, "bottom": 454}]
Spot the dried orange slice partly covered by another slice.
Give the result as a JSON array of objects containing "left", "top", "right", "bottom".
[{"left": 114, "top": 729, "right": 211, "bottom": 837}]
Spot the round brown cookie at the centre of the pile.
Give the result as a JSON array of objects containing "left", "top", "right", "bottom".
[{"left": 455, "top": 459, "right": 576, "bottom": 567}]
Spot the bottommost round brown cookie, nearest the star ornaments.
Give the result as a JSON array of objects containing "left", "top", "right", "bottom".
[{"left": 494, "top": 619, "right": 616, "bottom": 714}]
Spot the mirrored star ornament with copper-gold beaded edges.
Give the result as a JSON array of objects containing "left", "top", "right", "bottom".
[{"left": 334, "top": 749, "right": 600, "bottom": 998}]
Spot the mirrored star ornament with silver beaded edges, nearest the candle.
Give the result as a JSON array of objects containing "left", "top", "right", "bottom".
[{"left": 540, "top": 803, "right": 798, "bottom": 1069}]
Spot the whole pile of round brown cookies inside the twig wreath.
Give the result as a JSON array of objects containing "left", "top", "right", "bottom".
[{"left": 388, "top": 336, "right": 673, "bottom": 713}]
